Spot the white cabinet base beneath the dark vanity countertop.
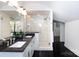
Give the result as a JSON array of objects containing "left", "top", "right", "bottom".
[{"left": 0, "top": 36, "right": 36, "bottom": 57}]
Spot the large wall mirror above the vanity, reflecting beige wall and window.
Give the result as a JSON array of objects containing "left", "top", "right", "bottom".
[{"left": 0, "top": 10, "right": 24, "bottom": 38}]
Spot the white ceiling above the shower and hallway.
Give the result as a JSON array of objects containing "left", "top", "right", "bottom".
[{"left": 0, "top": 1, "right": 79, "bottom": 22}]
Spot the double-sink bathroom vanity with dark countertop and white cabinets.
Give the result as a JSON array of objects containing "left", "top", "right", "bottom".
[{"left": 0, "top": 34, "right": 38, "bottom": 57}]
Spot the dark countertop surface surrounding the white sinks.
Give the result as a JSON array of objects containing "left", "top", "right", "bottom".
[{"left": 0, "top": 35, "right": 34, "bottom": 52}]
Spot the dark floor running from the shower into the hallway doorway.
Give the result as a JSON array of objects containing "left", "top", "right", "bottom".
[{"left": 33, "top": 36, "right": 78, "bottom": 57}]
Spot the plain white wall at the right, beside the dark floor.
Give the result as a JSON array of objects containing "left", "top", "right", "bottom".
[{"left": 65, "top": 20, "right": 79, "bottom": 56}]
